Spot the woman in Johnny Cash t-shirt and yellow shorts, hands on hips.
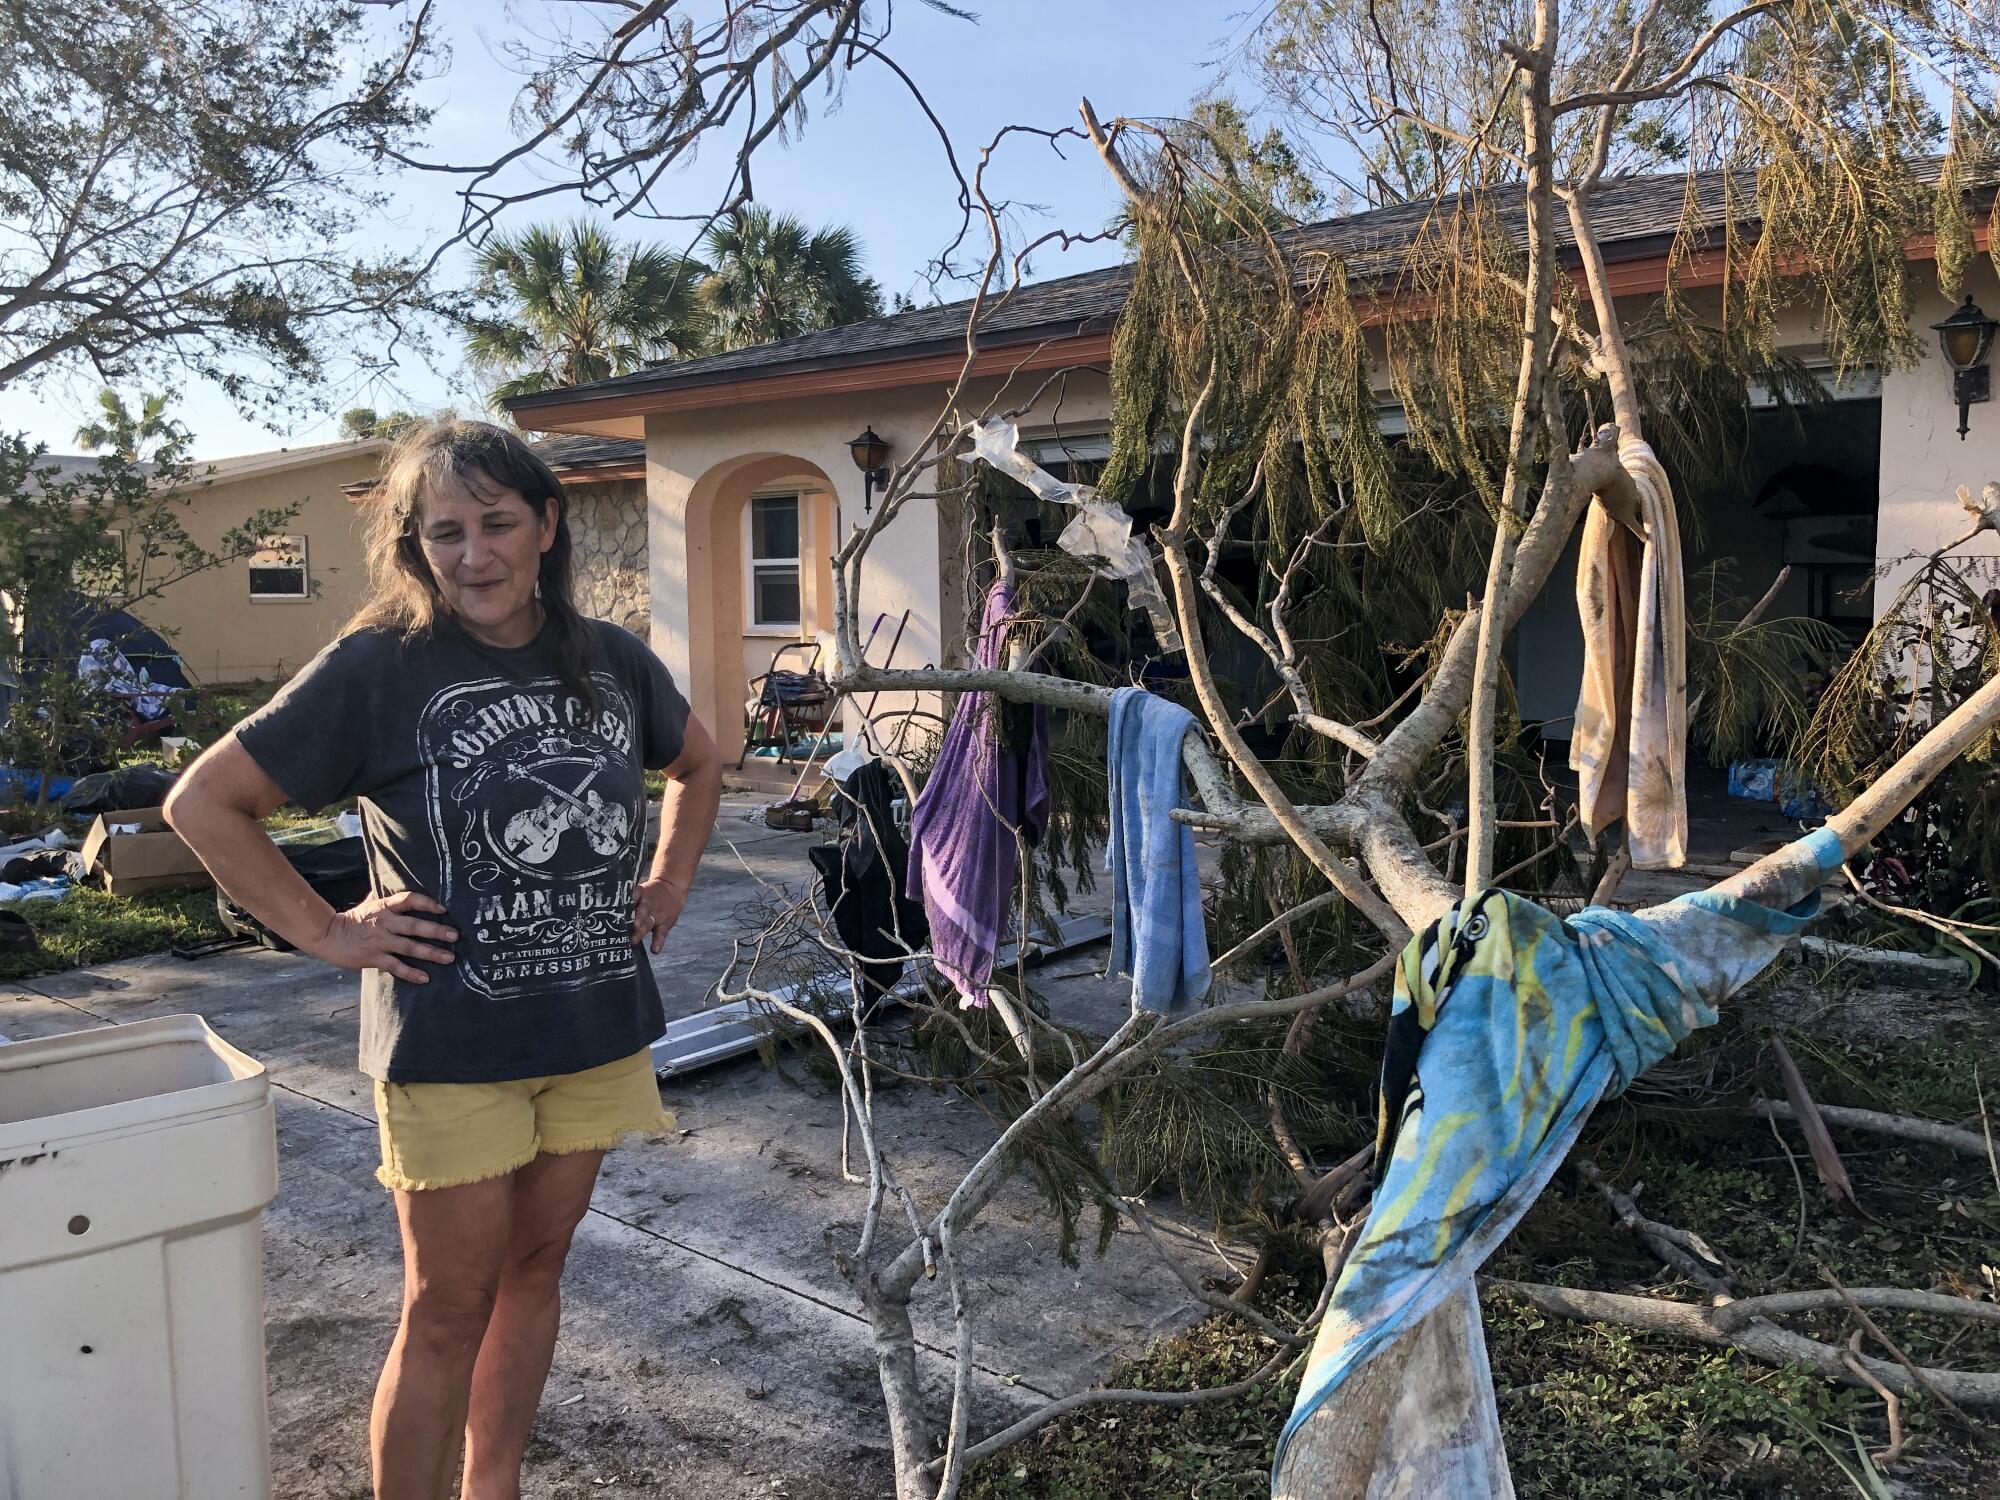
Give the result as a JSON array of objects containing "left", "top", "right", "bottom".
[{"left": 166, "top": 420, "right": 722, "bottom": 1500}]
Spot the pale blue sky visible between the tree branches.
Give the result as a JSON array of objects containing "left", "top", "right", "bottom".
[{"left": 0, "top": 0, "right": 1242, "bottom": 458}]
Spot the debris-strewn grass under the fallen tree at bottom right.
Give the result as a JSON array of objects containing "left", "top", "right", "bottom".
[{"left": 966, "top": 988, "right": 2000, "bottom": 1500}]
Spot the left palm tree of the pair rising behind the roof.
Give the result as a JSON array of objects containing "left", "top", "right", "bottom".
[{"left": 466, "top": 220, "right": 708, "bottom": 400}]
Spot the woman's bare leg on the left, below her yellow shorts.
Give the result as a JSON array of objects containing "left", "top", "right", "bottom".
[{"left": 368, "top": 1176, "right": 514, "bottom": 1500}]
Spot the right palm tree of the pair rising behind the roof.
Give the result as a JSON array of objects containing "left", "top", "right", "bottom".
[{"left": 700, "top": 204, "right": 882, "bottom": 350}]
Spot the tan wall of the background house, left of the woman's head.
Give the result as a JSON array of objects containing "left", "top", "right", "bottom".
[{"left": 134, "top": 452, "right": 380, "bottom": 682}]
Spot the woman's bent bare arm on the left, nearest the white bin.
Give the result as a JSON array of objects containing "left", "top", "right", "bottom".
[{"left": 164, "top": 736, "right": 458, "bottom": 984}]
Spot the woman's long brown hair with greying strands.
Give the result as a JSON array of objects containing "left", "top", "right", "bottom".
[{"left": 342, "top": 416, "right": 598, "bottom": 712}]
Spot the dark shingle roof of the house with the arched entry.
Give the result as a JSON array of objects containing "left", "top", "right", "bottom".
[{"left": 506, "top": 162, "right": 1976, "bottom": 416}]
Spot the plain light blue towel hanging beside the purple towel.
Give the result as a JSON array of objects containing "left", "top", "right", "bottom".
[{"left": 1108, "top": 688, "right": 1208, "bottom": 1014}]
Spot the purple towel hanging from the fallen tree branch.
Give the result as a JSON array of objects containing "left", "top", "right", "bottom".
[{"left": 908, "top": 584, "right": 1048, "bottom": 1006}]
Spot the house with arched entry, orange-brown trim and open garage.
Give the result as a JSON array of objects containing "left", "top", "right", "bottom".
[{"left": 506, "top": 176, "right": 2000, "bottom": 756}]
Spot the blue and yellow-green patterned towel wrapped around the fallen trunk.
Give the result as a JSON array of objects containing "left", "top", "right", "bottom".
[{"left": 1274, "top": 828, "right": 1840, "bottom": 1500}]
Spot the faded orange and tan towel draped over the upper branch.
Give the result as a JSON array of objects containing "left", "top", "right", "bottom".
[{"left": 1570, "top": 438, "right": 1688, "bottom": 870}]
